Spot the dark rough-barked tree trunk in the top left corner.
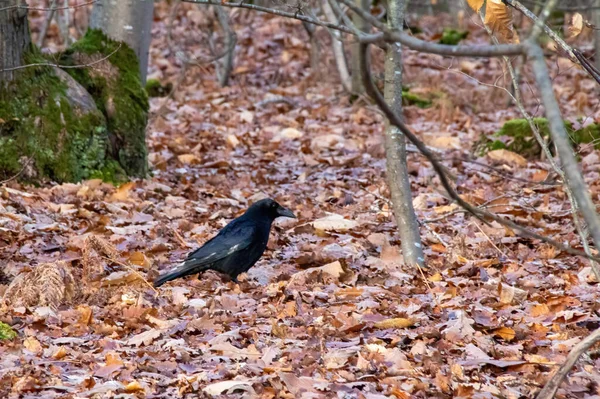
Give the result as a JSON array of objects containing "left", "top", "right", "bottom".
[{"left": 0, "top": 0, "right": 31, "bottom": 86}]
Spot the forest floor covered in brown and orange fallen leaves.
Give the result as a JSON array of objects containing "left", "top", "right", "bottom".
[{"left": 0, "top": 2, "right": 600, "bottom": 399}]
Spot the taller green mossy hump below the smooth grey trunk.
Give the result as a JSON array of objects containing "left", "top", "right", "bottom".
[{"left": 61, "top": 29, "right": 149, "bottom": 177}]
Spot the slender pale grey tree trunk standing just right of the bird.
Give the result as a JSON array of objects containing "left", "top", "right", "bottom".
[{"left": 384, "top": 0, "right": 425, "bottom": 266}]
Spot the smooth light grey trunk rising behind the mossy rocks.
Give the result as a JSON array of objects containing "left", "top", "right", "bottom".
[{"left": 90, "top": 0, "right": 154, "bottom": 84}]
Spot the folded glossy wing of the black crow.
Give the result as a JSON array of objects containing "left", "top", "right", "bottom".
[{"left": 184, "top": 220, "right": 256, "bottom": 267}]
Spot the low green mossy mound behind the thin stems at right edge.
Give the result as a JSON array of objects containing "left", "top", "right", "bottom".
[{"left": 474, "top": 118, "right": 600, "bottom": 158}]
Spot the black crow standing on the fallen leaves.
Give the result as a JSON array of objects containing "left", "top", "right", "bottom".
[{"left": 154, "top": 198, "right": 296, "bottom": 287}]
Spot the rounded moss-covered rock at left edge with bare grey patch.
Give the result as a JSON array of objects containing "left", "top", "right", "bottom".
[{"left": 0, "top": 51, "right": 108, "bottom": 182}]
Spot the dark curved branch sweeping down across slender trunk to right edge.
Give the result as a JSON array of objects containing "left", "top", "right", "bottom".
[{"left": 360, "top": 42, "right": 600, "bottom": 261}]
